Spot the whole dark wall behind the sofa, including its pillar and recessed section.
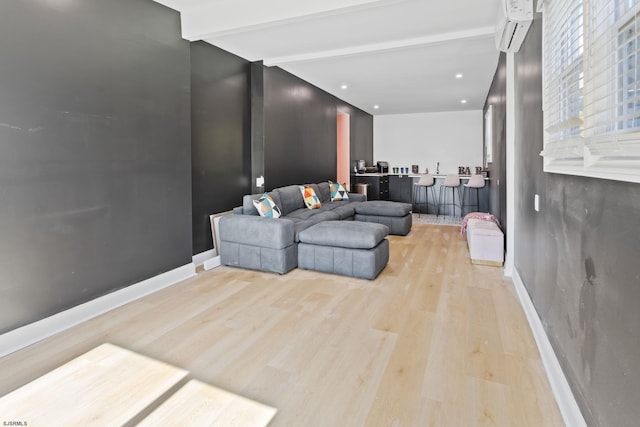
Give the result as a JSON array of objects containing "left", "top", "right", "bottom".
[{"left": 191, "top": 60, "right": 373, "bottom": 254}]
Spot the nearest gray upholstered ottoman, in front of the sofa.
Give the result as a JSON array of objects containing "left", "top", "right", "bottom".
[{"left": 298, "top": 221, "right": 389, "bottom": 280}]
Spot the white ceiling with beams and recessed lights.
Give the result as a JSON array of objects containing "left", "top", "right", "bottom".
[{"left": 155, "top": 0, "right": 499, "bottom": 115}]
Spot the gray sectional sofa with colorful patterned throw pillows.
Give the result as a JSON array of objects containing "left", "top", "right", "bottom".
[{"left": 219, "top": 182, "right": 411, "bottom": 274}]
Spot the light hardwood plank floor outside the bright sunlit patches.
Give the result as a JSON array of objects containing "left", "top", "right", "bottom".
[{"left": 0, "top": 224, "right": 563, "bottom": 426}]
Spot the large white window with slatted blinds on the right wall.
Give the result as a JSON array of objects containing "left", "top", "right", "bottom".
[{"left": 540, "top": 0, "right": 640, "bottom": 182}]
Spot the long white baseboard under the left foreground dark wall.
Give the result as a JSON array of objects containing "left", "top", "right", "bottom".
[{"left": 0, "top": 263, "right": 196, "bottom": 357}]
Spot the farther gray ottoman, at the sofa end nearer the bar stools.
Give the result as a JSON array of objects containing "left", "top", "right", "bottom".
[{"left": 353, "top": 200, "right": 412, "bottom": 236}]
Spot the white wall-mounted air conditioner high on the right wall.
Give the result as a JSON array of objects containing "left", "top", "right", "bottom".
[{"left": 496, "top": 0, "right": 533, "bottom": 52}]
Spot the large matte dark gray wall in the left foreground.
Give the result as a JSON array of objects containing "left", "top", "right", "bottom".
[{"left": 0, "top": 0, "right": 191, "bottom": 333}]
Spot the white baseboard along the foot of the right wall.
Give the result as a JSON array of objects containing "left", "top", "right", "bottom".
[{"left": 511, "top": 268, "right": 587, "bottom": 427}]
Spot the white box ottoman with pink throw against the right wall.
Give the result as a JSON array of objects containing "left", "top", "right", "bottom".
[{"left": 467, "top": 218, "right": 504, "bottom": 267}]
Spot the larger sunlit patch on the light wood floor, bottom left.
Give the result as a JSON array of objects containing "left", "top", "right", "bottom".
[{"left": 0, "top": 343, "right": 187, "bottom": 426}]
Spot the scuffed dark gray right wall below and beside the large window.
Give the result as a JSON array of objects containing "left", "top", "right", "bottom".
[{"left": 515, "top": 15, "right": 640, "bottom": 427}]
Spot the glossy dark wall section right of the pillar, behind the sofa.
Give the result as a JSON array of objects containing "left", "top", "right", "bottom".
[{"left": 264, "top": 67, "right": 373, "bottom": 190}]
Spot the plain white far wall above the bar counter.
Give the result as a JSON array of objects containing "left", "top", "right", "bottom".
[{"left": 373, "top": 110, "right": 483, "bottom": 174}]
